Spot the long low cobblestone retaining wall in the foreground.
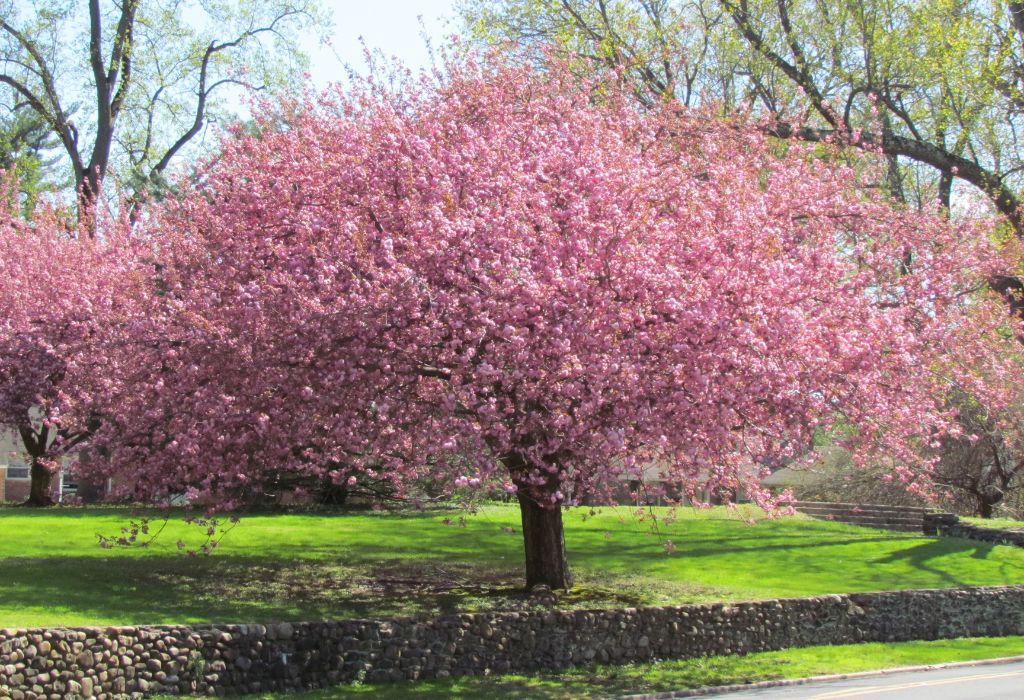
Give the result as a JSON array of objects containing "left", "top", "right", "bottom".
[{"left": 0, "top": 586, "right": 1024, "bottom": 700}]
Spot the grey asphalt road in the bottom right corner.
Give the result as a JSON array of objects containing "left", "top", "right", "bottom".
[{"left": 712, "top": 662, "right": 1024, "bottom": 700}]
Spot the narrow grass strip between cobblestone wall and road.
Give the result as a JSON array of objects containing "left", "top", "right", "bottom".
[{"left": 153, "top": 637, "right": 1024, "bottom": 700}]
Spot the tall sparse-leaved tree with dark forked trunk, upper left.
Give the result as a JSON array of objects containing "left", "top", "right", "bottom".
[{"left": 0, "top": 0, "right": 315, "bottom": 212}]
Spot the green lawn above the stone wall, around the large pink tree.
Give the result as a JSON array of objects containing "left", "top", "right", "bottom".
[{"left": 0, "top": 507, "right": 1024, "bottom": 626}]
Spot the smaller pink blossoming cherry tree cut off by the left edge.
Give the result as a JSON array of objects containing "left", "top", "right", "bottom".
[{"left": 0, "top": 184, "right": 147, "bottom": 506}]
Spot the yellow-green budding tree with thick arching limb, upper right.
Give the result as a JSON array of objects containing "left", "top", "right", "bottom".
[{"left": 462, "top": 0, "right": 1024, "bottom": 229}]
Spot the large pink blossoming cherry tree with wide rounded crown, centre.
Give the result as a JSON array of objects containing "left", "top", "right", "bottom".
[{"left": 79, "top": 59, "right": 1011, "bottom": 587}]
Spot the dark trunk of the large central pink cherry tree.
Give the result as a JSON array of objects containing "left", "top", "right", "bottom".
[{"left": 517, "top": 488, "right": 572, "bottom": 590}]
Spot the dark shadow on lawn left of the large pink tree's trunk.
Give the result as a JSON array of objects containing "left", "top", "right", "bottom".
[{"left": 0, "top": 556, "right": 525, "bottom": 624}]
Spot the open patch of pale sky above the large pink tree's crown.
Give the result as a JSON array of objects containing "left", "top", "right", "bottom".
[{"left": 306, "top": 0, "right": 457, "bottom": 88}]
